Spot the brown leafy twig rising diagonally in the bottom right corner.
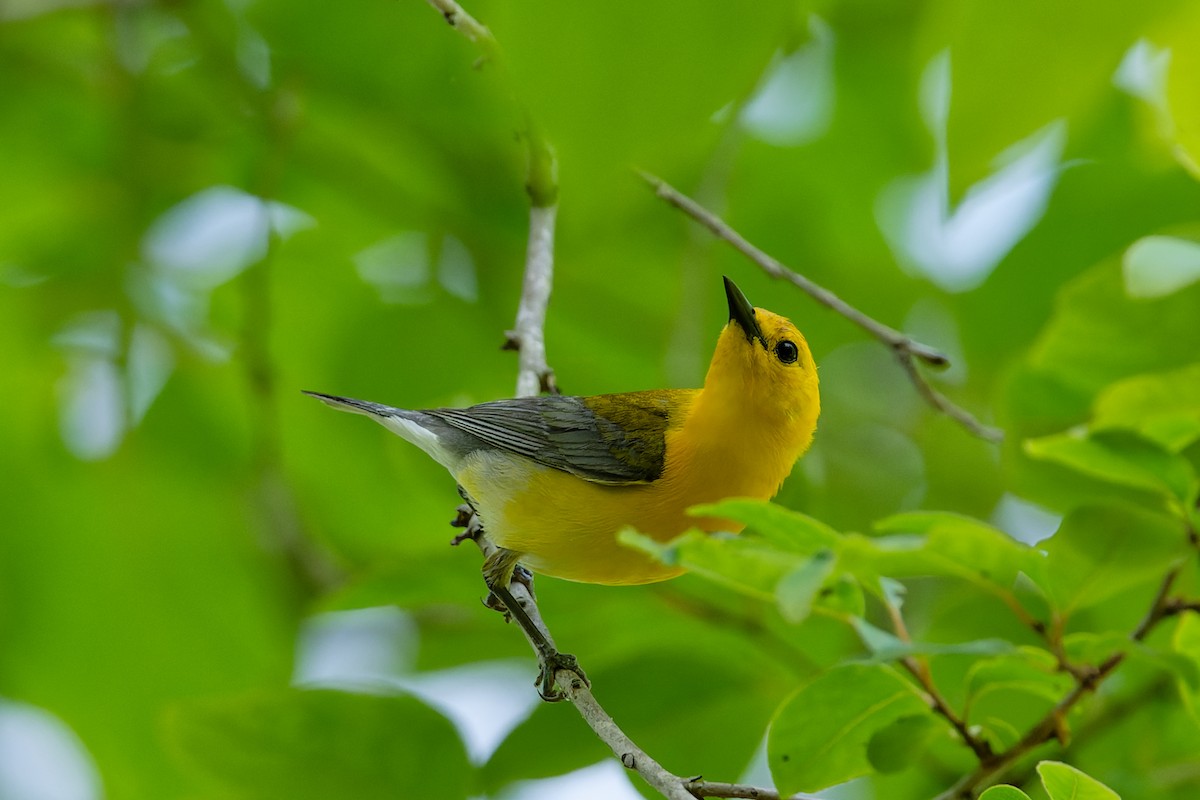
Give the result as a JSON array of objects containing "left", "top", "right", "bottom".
[{"left": 936, "top": 566, "right": 1192, "bottom": 800}]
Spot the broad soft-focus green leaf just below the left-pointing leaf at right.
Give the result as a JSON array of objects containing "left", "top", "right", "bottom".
[{"left": 1042, "top": 506, "right": 1186, "bottom": 615}]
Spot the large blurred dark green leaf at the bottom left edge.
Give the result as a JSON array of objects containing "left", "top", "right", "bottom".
[{"left": 168, "top": 690, "right": 470, "bottom": 800}]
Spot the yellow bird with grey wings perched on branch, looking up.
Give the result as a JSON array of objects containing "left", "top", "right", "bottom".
[{"left": 308, "top": 278, "right": 821, "bottom": 588}]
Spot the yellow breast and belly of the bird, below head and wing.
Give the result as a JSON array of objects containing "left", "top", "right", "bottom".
[{"left": 456, "top": 381, "right": 816, "bottom": 584}]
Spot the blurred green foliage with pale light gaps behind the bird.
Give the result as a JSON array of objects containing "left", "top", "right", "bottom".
[{"left": 0, "top": 0, "right": 1200, "bottom": 800}]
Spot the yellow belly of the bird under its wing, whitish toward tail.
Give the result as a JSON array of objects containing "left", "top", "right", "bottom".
[{"left": 456, "top": 452, "right": 778, "bottom": 584}]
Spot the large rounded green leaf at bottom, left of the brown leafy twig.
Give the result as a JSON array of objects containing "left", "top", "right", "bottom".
[{"left": 767, "top": 664, "right": 930, "bottom": 794}]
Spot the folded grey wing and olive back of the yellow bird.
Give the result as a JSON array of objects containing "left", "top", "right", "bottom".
[{"left": 421, "top": 391, "right": 684, "bottom": 486}]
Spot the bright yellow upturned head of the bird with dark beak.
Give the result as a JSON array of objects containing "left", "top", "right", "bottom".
[{"left": 704, "top": 278, "right": 821, "bottom": 450}]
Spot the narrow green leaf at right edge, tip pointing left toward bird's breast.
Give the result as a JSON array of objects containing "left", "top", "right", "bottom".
[{"left": 1025, "top": 428, "right": 1195, "bottom": 503}]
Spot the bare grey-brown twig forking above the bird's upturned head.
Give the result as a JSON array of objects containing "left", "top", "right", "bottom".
[{"left": 638, "top": 170, "right": 1004, "bottom": 441}]
